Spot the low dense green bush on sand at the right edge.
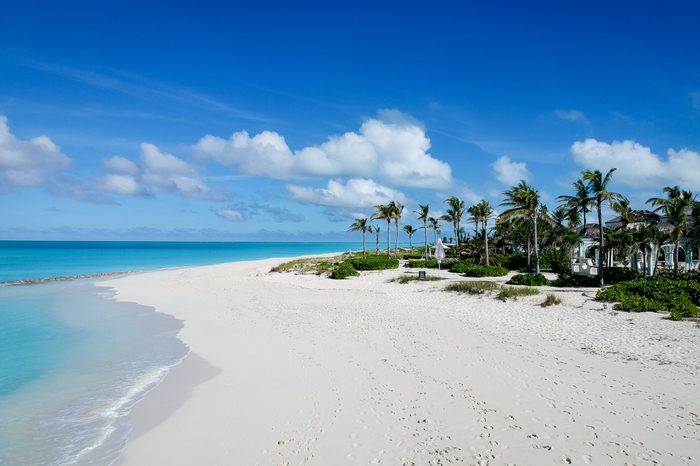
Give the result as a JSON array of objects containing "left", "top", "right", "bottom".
[{"left": 597, "top": 278, "right": 700, "bottom": 320}]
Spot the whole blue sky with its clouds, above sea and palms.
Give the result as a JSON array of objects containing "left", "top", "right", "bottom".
[{"left": 0, "top": 0, "right": 700, "bottom": 241}]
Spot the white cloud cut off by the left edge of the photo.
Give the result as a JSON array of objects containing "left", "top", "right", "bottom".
[{"left": 0, "top": 115, "right": 71, "bottom": 191}]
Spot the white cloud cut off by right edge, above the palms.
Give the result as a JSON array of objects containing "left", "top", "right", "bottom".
[{"left": 571, "top": 139, "right": 700, "bottom": 190}]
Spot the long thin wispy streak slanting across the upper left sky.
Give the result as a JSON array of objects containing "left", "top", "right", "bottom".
[{"left": 23, "top": 60, "right": 274, "bottom": 123}]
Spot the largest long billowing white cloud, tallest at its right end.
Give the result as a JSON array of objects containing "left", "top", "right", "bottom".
[{"left": 194, "top": 110, "right": 452, "bottom": 188}]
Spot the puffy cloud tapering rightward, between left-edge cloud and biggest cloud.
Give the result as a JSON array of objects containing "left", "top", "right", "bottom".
[{"left": 98, "top": 143, "right": 226, "bottom": 200}]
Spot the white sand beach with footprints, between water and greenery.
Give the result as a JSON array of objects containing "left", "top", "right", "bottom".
[{"left": 102, "top": 260, "right": 700, "bottom": 465}]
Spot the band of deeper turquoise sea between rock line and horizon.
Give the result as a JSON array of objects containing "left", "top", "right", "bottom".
[{"left": 0, "top": 241, "right": 362, "bottom": 282}]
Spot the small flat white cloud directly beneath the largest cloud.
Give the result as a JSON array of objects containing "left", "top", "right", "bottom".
[{"left": 287, "top": 178, "right": 406, "bottom": 208}]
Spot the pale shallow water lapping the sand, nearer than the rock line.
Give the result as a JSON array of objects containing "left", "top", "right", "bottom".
[{"left": 0, "top": 281, "right": 187, "bottom": 465}]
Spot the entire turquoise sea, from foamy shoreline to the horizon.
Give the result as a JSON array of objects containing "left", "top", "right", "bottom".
[{"left": 0, "top": 241, "right": 358, "bottom": 466}]
